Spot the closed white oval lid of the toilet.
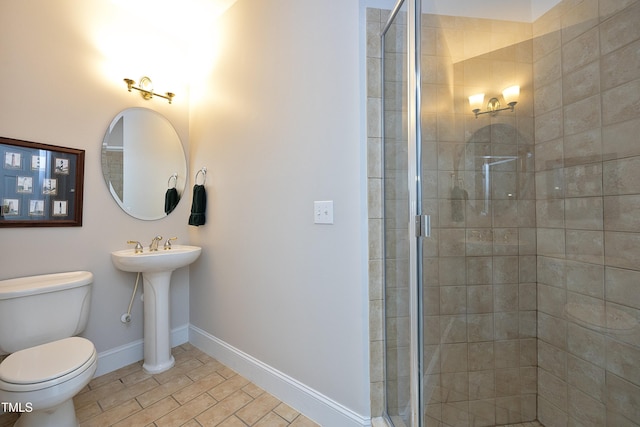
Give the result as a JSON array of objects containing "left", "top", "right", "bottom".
[{"left": 0, "top": 337, "right": 95, "bottom": 384}]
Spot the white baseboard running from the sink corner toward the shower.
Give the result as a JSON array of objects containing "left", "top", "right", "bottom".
[{"left": 189, "top": 325, "right": 371, "bottom": 427}]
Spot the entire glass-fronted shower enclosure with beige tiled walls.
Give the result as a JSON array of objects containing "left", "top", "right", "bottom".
[{"left": 368, "top": 0, "right": 640, "bottom": 427}]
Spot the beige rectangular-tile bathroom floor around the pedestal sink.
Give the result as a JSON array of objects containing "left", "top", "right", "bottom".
[{"left": 0, "top": 344, "right": 319, "bottom": 427}]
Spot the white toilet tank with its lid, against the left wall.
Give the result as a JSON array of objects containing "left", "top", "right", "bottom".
[{"left": 0, "top": 271, "right": 93, "bottom": 354}]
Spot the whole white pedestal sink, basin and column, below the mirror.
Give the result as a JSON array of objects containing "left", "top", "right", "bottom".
[{"left": 111, "top": 245, "right": 202, "bottom": 374}]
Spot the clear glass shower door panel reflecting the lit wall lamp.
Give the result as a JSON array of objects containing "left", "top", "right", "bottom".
[{"left": 420, "top": 10, "right": 537, "bottom": 427}]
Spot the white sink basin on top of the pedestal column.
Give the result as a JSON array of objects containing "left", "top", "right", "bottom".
[{"left": 111, "top": 245, "right": 202, "bottom": 273}]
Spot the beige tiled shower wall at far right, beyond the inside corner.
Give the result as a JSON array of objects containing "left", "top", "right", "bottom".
[{"left": 533, "top": 0, "right": 640, "bottom": 427}]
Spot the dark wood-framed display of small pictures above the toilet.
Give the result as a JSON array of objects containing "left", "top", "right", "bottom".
[{"left": 0, "top": 137, "right": 85, "bottom": 227}]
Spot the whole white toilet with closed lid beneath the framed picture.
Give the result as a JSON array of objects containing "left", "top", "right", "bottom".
[{"left": 0, "top": 271, "right": 98, "bottom": 427}]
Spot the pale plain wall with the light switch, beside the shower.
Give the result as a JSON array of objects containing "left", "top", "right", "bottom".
[{"left": 190, "top": 0, "right": 369, "bottom": 425}]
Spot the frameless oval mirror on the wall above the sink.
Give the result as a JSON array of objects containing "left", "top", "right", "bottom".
[{"left": 102, "top": 108, "right": 187, "bottom": 220}]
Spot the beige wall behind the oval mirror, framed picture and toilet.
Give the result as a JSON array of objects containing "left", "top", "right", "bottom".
[{"left": 0, "top": 0, "right": 190, "bottom": 364}]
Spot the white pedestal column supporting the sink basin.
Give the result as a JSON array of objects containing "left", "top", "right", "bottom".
[{"left": 142, "top": 271, "right": 176, "bottom": 374}]
